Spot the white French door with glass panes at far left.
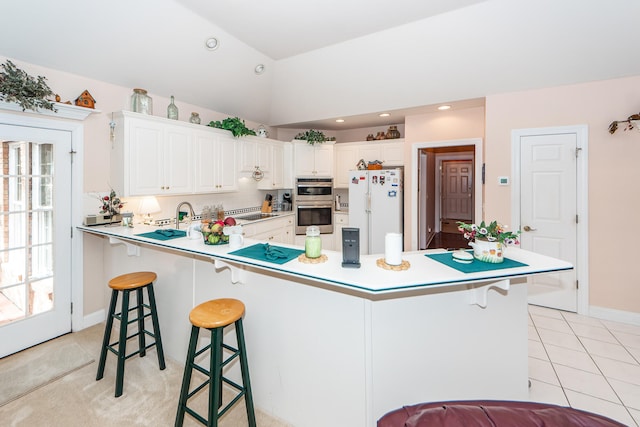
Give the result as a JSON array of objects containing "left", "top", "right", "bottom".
[{"left": 0, "top": 124, "right": 72, "bottom": 357}]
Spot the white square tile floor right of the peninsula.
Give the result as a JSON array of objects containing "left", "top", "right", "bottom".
[{"left": 529, "top": 306, "right": 640, "bottom": 427}]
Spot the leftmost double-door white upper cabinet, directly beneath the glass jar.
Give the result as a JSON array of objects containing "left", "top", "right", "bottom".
[{"left": 111, "top": 112, "right": 194, "bottom": 197}]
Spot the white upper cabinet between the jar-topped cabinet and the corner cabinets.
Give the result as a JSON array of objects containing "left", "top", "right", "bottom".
[{"left": 194, "top": 131, "right": 238, "bottom": 193}]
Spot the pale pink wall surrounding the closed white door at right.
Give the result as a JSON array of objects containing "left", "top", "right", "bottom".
[{"left": 485, "top": 76, "right": 640, "bottom": 313}]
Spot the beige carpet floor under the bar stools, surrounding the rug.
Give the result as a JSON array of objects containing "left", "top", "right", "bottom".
[{"left": 0, "top": 324, "right": 289, "bottom": 427}]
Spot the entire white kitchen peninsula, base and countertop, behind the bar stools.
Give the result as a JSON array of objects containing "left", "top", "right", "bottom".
[{"left": 79, "top": 226, "right": 572, "bottom": 426}]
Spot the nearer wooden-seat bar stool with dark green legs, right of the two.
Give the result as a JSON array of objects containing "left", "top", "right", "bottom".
[{"left": 175, "top": 298, "right": 256, "bottom": 427}]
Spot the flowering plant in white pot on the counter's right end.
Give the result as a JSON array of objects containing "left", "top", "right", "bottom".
[{"left": 458, "top": 221, "right": 520, "bottom": 264}]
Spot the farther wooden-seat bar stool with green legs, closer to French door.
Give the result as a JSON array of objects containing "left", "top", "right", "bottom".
[{"left": 96, "top": 271, "right": 165, "bottom": 397}]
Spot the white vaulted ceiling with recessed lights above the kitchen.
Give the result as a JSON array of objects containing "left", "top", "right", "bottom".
[{"left": 0, "top": 0, "right": 640, "bottom": 128}]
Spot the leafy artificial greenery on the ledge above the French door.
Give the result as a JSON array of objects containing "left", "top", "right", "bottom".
[{"left": 0, "top": 60, "right": 56, "bottom": 111}]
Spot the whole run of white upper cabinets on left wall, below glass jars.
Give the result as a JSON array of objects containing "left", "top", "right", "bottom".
[{"left": 111, "top": 111, "right": 237, "bottom": 197}]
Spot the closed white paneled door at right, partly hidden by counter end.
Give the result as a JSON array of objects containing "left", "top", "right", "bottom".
[{"left": 514, "top": 132, "right": 579, "bottom": 312}]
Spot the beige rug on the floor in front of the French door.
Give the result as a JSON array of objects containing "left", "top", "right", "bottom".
[{"left": 0, "top": 340, "right": 93, "bottom": 406}]
